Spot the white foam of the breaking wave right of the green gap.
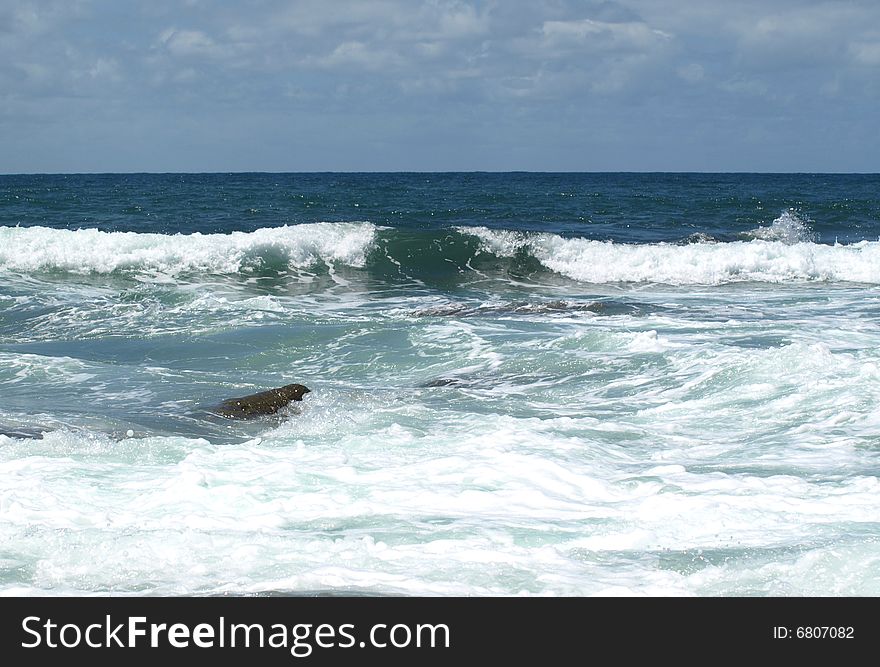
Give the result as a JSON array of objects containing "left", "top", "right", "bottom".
[{"left": 459, "top": 227, "right": 880, "bottom": 285}]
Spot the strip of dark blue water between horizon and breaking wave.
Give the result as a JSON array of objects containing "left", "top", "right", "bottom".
[{"left": 0, "top": 173, "right": 880, "bottom": 243}]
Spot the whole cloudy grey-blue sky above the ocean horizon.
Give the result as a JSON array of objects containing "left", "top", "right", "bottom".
[{"left": 0, "top": 0, "right": 880, "bottom": 173}]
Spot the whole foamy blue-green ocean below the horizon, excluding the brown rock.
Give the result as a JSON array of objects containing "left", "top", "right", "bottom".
[{"left": 0, "top": 173, "right": 880, "bottom": 596}]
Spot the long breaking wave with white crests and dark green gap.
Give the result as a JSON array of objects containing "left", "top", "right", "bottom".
[{"left": 0, "top": 217, "right": 880, "bottom": 285}]
